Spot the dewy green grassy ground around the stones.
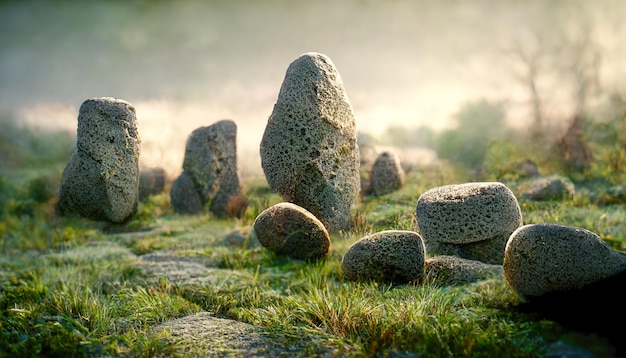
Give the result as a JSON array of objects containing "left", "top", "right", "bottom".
[{"left": 0, "top": 164, "right": 626, "bottom": 357}]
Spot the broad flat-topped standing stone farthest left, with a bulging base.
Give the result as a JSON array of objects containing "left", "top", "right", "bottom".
[{"left": 58, "top": 97, "right": 140, "bottom": 223}]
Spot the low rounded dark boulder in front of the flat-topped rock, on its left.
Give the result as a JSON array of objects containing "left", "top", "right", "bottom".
[{"left": 341, "top": 230, "right": 424, "bottom": 284}]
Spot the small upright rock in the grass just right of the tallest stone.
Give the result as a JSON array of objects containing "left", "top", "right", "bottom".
[{"left": 370, "top": 150, "right": 404, "bottom": 196}]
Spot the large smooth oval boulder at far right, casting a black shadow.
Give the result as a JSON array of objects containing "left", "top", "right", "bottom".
[{"left": 504, "top": 224, "right": 626, "bottom": 297}]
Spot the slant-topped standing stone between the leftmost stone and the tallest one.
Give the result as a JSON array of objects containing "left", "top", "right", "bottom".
[{"left": 170, "top": 120, "right": 243, "bottom": 216}]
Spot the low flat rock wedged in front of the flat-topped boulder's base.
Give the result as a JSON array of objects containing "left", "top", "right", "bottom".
[{"left": 424, "top": 256, "right": 502, "bottom": 286}]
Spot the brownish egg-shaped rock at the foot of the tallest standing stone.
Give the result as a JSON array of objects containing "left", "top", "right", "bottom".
[{"left": 253, "top": 203, "right": 330, "bottom": 260}]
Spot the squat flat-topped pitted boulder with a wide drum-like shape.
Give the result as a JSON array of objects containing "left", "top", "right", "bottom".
[{"left": 416, "top": 182, "right": 522, "bottom": 264}]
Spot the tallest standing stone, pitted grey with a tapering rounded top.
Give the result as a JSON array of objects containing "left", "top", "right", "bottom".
[{"left": 260, "top": 53, "right": 360, "bottom": 231}]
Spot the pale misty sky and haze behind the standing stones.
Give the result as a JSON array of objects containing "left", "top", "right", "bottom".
[{"left": 0, "top": 0, "right": 626, "bottom": 176}]
